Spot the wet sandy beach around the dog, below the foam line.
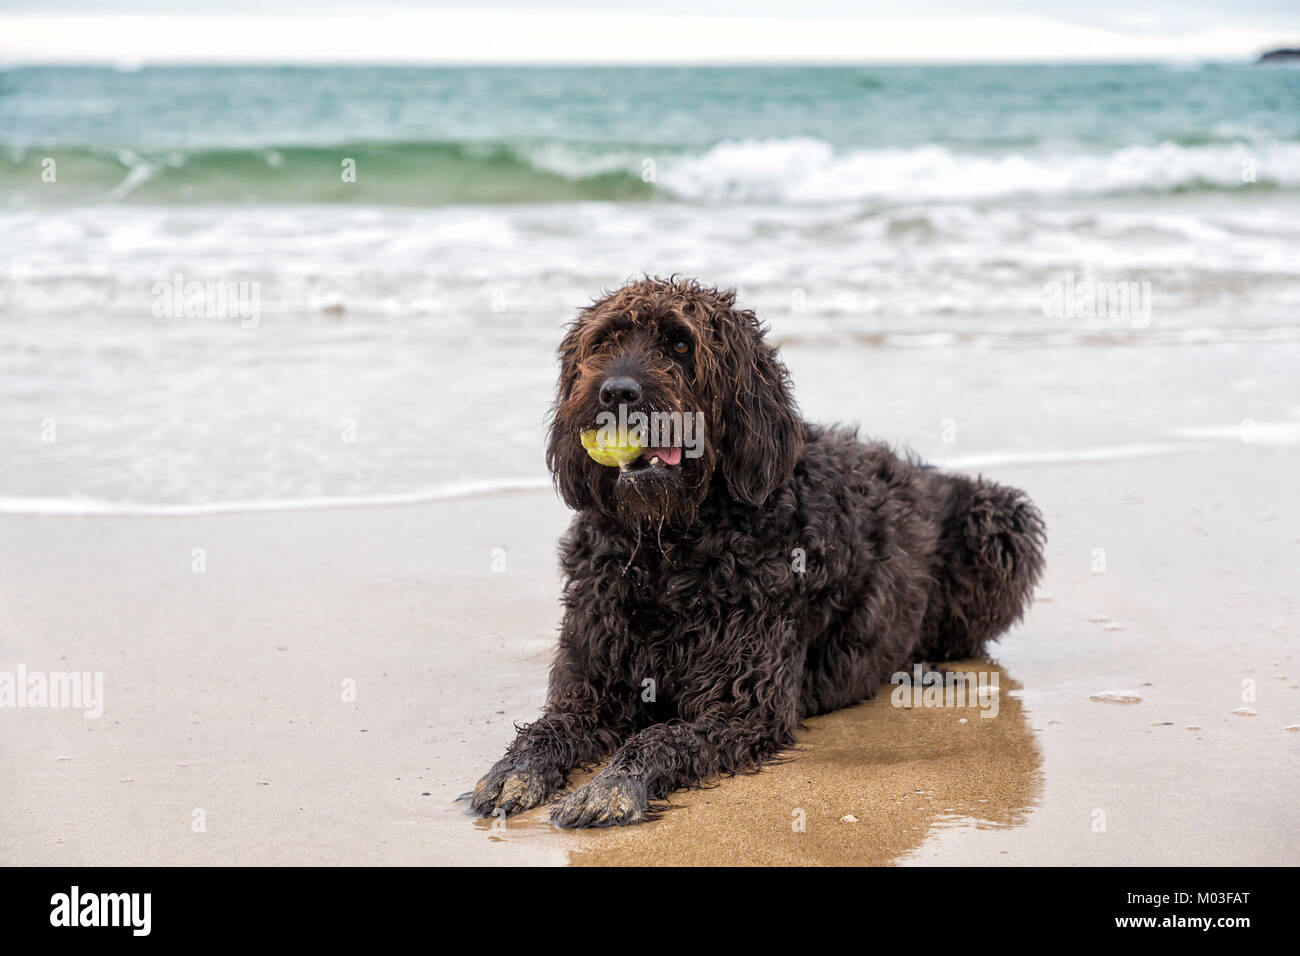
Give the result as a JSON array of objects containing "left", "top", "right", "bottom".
[{"left": 0, "top": 441, "right": 1300, "bottom": 865}]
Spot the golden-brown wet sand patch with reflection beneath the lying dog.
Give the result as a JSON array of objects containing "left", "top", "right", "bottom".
[{"left": 477, "top": 661, "right": 1041, "bottom": 866}]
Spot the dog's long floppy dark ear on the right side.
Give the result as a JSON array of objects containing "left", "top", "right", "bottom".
[{"left": 714, "top": 308, "right": 803, "bottom": 505}]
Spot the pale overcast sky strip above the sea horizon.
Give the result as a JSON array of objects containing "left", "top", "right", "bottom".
[{"left": 0, "top": 0, "right": 1300, "bottom": 64}]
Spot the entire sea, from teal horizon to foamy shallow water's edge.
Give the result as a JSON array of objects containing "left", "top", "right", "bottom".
[{"left": 0, "top": 64, "right": 1300, "bottom": 512}]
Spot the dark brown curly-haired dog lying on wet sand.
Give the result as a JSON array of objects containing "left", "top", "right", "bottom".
[{"left": 468, "top": 278, "right": 1045, "bottom": 827}]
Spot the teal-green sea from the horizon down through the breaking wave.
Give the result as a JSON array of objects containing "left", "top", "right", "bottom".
[{"left": 0, "top": 64, "right": 1300, "bottom": 206}]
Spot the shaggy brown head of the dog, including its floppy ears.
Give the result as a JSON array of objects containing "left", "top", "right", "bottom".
[{"left": 546, "top": 278, "right": 803, "bottom": 527}]
